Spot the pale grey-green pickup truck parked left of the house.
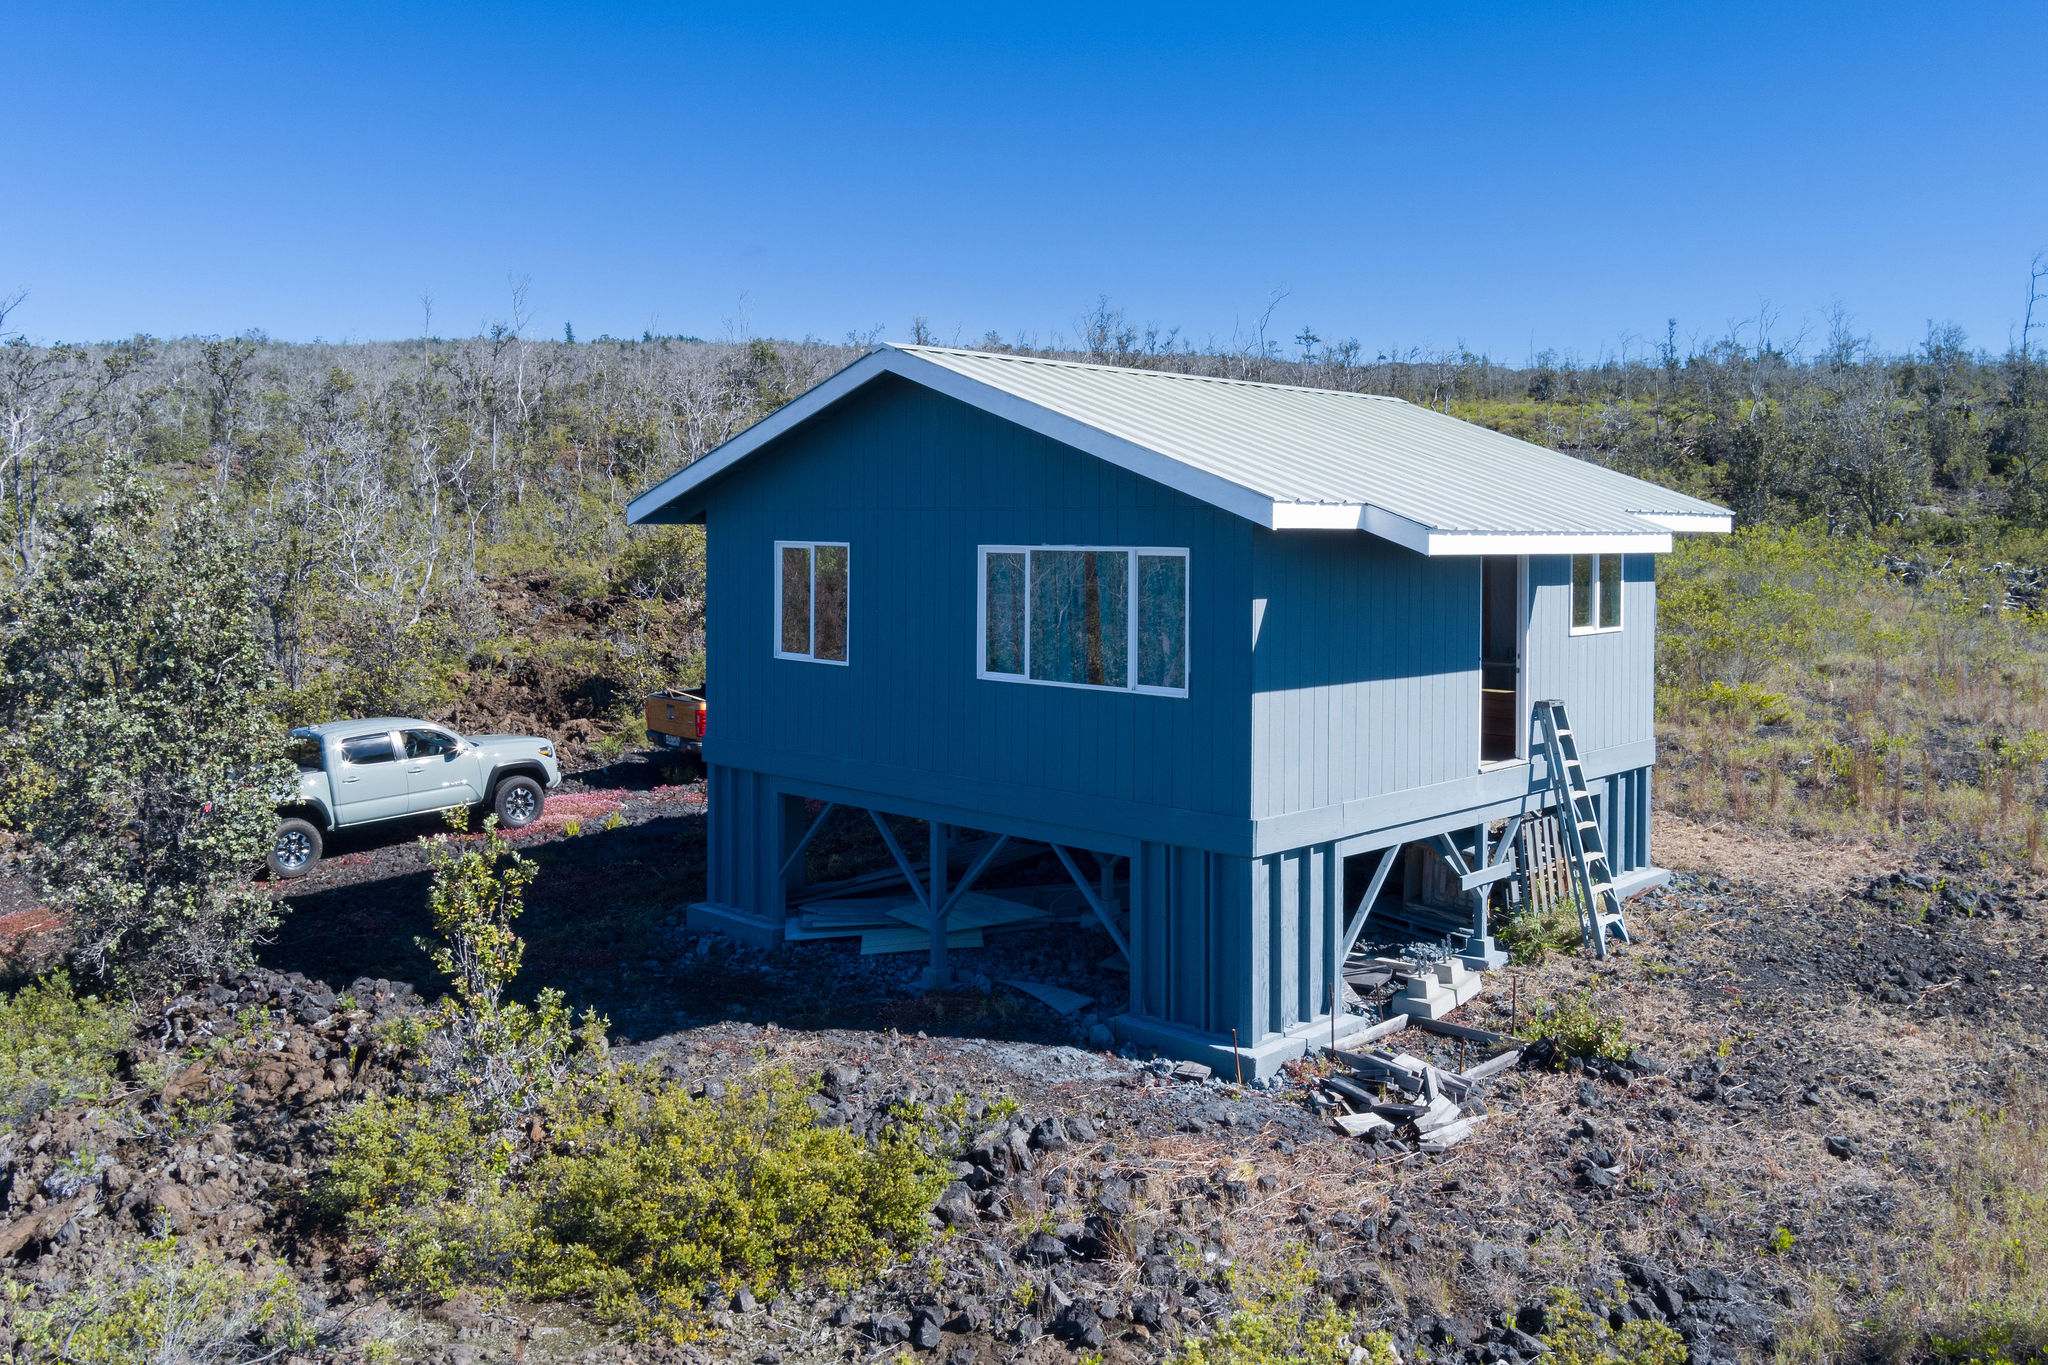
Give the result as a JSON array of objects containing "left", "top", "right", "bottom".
[{"left": 266, "top": 716, "right": 561, "bottom": 878}]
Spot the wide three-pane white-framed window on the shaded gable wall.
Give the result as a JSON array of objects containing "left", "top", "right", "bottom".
[{"left": 979, "top": 544, "right": 1188, "bottom": 696}]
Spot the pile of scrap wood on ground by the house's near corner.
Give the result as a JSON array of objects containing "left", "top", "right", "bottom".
[{"left": 1309, "top": 1015, "right": 1522, "bottom": 1156}]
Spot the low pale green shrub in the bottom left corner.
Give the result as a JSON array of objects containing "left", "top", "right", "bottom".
[{"left": 8, "top": 1236, "right": 315, "bottom": 1365}]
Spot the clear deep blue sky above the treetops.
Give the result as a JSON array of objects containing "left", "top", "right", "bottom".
[{"left": 0, "top": 0, "right": 2048, "bottom": 360}]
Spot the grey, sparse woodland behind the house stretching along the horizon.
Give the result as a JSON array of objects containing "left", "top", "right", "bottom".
[{"left": 0, "top": 264, "right": 2048, "bottom": 732}]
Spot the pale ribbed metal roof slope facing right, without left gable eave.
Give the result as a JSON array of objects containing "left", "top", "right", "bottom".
[{"left": 899, "top": 346, "right": 1726, "bottom": 534}]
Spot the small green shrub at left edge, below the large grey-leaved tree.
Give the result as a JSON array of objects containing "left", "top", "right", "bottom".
[{"left": 0, "top": 972, "right": 131, "bottom": 1132}]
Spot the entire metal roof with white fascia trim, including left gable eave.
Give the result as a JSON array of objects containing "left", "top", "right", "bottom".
[{"left": 627, "top": 346, "right": 1731, "bottom": 555}]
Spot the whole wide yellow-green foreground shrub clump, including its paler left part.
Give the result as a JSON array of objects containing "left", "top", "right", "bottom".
[{"left": 326, "top": 1068, "right": 948, "bottom": 1334}]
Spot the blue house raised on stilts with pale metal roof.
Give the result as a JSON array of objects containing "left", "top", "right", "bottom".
[{"left": 629, "top": 346, "right": 1731, "bottom": 1076}]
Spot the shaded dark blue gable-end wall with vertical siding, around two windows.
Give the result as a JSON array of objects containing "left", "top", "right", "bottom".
[{"left": 707, "top": 381, "right": 1251, "bottom": 833}]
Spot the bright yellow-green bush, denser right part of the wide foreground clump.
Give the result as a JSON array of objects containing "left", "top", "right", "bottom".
[{"left": 528, "top": 1070, "right": 948, "bottom": 1324}]
